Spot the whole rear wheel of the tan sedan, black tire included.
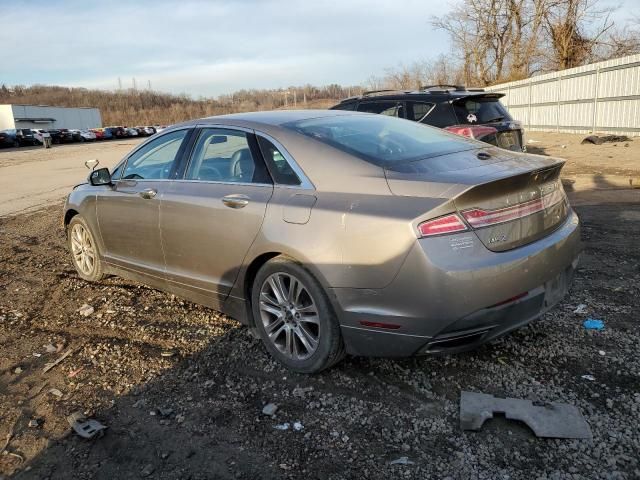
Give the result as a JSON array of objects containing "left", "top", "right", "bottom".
[{"left": 251, "top": 256, "right": 345, "bottom": 373}]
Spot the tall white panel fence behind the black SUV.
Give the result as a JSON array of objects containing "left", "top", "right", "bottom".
[{"left": 486, "top": 55, "right": 640, "bottom": 135}]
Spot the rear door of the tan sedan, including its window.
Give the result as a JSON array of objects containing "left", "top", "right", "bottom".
[{"left": 160, "top": 126, "right": 273, "bottom": 308}]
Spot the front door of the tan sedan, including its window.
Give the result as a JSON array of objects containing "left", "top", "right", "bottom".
[{"left": 97, "top": 129, "right": 190, "bottom": 279}]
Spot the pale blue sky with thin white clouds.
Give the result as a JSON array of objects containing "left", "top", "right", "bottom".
[{"left": 0, "top": 0, "right": 640, "bottom": 97}]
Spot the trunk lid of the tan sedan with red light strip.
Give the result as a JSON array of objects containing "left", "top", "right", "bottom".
[{"left": 385, "top": 148, "right": 569, "bottom": 252}]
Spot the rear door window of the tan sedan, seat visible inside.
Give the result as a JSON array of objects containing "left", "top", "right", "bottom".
[{"left": 185, "top": 128, "right": 270, "bottom": 183}]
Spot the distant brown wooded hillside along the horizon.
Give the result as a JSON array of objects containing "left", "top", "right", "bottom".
[{"left": 0, "top": 85, "right": 355, "bottom": 125}]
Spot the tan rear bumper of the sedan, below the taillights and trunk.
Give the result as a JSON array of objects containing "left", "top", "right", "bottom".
[{"left": 332, "top": 212, "right": 581, "bottom": 356}]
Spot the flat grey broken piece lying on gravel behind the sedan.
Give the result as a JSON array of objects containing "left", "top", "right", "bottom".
[{"left": 460, "top": 391, "right": 592, "bottom": 439}]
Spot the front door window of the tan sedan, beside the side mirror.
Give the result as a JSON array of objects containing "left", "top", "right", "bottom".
[{"left": 122, "top": 129, "right": 189, "bottom": 180}]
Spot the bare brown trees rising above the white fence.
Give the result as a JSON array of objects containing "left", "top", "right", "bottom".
[{"left": 431, "top": 0, "right": 640, "bottom": 85}]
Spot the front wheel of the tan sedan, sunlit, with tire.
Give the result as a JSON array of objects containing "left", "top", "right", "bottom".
[{"left": 67, "top": 215, "right": 105, "bottom": 282}]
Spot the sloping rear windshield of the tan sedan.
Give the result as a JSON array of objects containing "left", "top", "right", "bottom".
[{"left": 284, "top": 114, "right": 478, "bottom": 166}]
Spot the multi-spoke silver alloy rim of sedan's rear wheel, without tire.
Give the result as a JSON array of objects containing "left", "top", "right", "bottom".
[{"left": 260, "top": 272, "right": 320, "bottom": 360}]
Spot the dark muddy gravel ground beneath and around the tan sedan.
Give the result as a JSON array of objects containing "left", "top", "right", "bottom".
[{"left": 0, "top": 200, "right": 640, "bottom": 479}]
